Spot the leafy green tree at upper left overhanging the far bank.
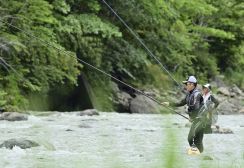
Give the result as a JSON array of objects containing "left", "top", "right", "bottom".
[{"left": 0, "top": 0, "right": 80, "bottom": 109}]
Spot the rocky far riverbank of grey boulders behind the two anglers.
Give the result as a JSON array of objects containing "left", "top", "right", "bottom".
[{"left": 113, "top": 81, "right": 244, "bottom": 115}]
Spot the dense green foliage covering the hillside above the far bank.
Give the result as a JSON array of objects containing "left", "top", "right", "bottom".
[{"left": 0, "top": 0, "right": 244, "bottom": 110}]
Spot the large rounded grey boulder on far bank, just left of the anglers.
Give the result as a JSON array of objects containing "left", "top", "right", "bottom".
[{"left": 130, "top": 95, "right": 160, "bottom": 113}]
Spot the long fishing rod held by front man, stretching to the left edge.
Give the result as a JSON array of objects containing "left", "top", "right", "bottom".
[{"left": 0, "top": 19, "right": 189, "bottom": 120}]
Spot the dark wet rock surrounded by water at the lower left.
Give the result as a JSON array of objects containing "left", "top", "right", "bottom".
[{"left": 0, "top": 139, "right": 39, "bottom": 149}]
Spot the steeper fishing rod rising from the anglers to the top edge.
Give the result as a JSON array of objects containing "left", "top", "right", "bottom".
[{"left": 102, "top": 0, "right": 182, "bottom": 88}]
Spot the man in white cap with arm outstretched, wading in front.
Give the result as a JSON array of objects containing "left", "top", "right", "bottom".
[{"left": 164, "top": 76, "right": 204, "bottom": 154}]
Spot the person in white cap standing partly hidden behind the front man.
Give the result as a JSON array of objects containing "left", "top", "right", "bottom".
[{"left": 202, "top": 83, "right": 219, "bottom": 134}]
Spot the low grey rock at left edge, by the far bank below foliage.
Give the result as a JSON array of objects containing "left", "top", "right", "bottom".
[{"left": 0, "top": 112, "right": 28, "bottom": 121}]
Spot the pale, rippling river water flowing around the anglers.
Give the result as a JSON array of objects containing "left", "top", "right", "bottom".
[{"left": 0, "top": 112, "right": 244, "bottom": 168}]
